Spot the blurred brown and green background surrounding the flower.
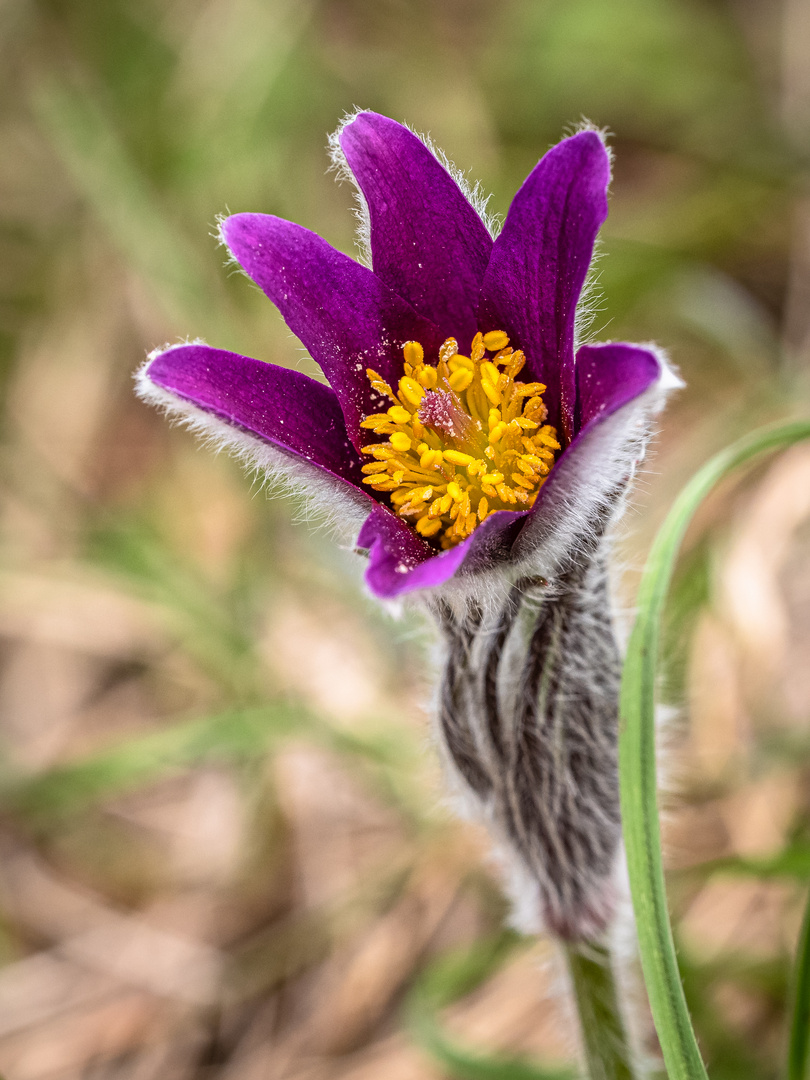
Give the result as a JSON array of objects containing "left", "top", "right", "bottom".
[{"left": 0, "top": 0, "right": 810, "bottom": 1080}]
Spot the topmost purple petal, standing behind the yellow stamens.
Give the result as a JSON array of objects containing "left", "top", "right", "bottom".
[{"left": 340, "top": 112, "right": 492, "bottom": 352}]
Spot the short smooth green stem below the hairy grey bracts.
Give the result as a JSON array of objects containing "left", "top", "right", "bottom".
[{"left": 566, "top": 942, "right": 634, "bottom": 1080}]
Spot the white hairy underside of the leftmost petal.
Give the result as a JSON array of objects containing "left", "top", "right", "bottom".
[{"left": 135, "top": 354, "right": 372, "bottom": 544}]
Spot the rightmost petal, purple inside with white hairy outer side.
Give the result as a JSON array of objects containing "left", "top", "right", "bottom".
[{"left": 513, "top": 345, "right": 663, "bottom": 573}]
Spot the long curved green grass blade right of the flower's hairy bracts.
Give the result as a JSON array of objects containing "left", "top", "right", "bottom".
[{"left": 619, "top": 421, "right": 810, "bottom": 1080}]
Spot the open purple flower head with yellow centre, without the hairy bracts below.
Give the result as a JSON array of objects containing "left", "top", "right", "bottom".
[{"left": 138, "top": 112, "right": 676, "bottom": 597}]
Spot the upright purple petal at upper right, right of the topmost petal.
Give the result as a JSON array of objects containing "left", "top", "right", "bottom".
[{"left": 480, "top": 132, "right": 610, "bottom": 441}]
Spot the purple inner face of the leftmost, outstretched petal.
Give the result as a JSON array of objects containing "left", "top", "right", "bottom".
[{"left": 146, "top": 345, "right": 367, "bottom": 495}]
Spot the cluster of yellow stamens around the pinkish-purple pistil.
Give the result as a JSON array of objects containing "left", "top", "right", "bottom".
[{"left": 362, "top": 330, "right": 561, "bottom": 549}]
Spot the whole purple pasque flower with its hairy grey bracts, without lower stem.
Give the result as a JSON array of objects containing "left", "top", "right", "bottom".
[{"left": 138, "top": 112, "right": 677, "bottom": 939}]
